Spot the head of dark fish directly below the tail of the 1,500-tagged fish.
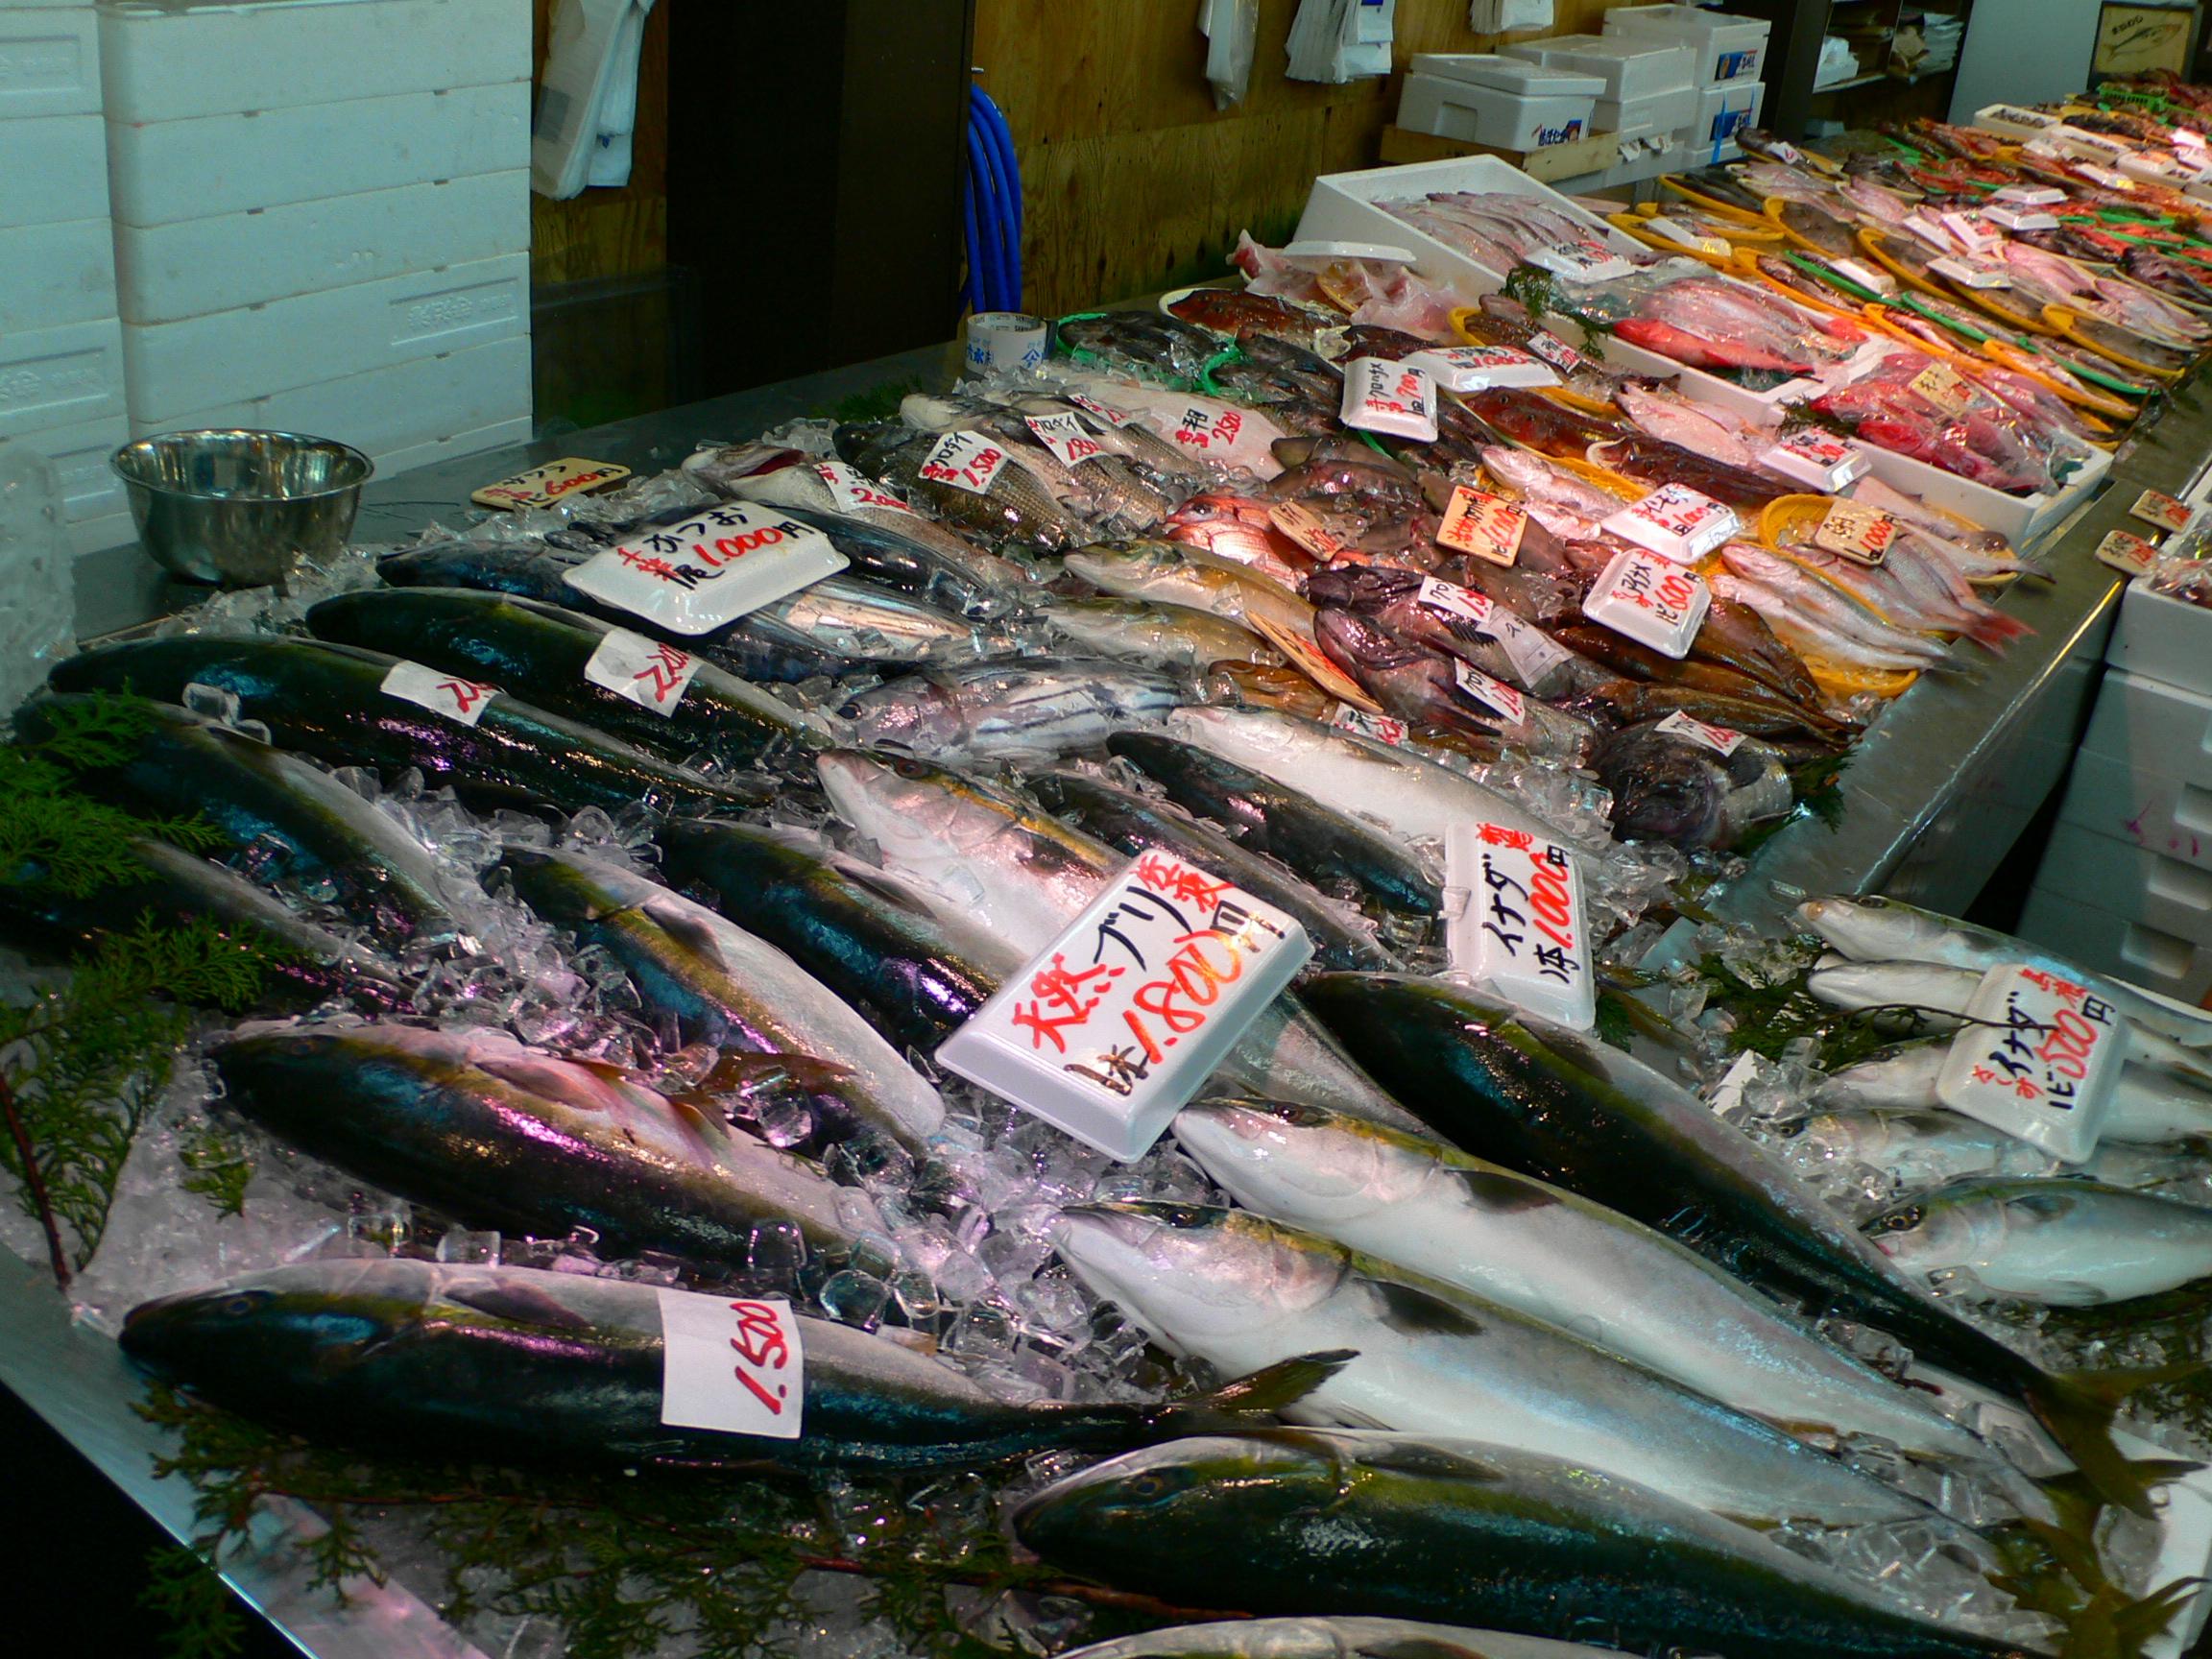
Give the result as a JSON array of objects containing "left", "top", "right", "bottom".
[{"left": 1013, "top": 1433, "right": 1345, "bottom": 1566}]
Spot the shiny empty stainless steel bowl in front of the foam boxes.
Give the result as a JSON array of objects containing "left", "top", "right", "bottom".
[{"left": 108, "top": 431, "right": 376, "bottom": 589}]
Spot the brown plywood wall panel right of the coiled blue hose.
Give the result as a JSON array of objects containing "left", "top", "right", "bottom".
[{"left": 975, "top": 0, "right": 1622, "bottom": 314}]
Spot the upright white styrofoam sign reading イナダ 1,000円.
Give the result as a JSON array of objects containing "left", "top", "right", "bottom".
[{"left": 1445, "top": 823, "right": 1597, "bottom": 1031}]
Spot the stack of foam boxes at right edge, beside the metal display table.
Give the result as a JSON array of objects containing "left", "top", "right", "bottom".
[{"left": 2020, "top": 582, "right": 2212, "bottom": 1002}]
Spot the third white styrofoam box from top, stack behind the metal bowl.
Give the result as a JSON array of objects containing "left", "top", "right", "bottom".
[{"left": 115, "top": 168, "right": 531, "bottom": 323}]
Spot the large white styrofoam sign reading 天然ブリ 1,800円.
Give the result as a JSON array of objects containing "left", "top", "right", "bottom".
[{"left": 938, "top": 850, "right": 1314, "bottom": 1162}]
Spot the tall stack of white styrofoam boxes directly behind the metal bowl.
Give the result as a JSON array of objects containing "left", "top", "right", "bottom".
[{"left": 100, "top": 0, "right": 531, "bottom": 491}]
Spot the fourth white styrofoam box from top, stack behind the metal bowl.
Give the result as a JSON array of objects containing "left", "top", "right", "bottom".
[{"left": 124, "top": 254, "right": 531, "bottom": 431}]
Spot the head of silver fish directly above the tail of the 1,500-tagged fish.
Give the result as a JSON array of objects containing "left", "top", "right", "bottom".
[{"left": 1053, "top": 1203, "right": 1352, "bottom": 1347}]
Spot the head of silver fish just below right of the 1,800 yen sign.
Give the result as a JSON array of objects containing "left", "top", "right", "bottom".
[{"left": 1174, "top": 1097, "right": 1435, "bottom": 1230}]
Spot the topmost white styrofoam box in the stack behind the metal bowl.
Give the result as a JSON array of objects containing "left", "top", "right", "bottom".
[{"left": 100, "top": 0, "right": 531, "bottom": 122}]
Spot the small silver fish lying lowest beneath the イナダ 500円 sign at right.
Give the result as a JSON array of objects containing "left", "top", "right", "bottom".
[{"left": 1867, "top": 1177, "right": 2212, "bottom": 1308}]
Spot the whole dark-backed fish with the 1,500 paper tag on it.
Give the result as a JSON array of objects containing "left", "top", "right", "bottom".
[{"left": 119, "top": 1259, "right": 1330, "bottom": 1471}]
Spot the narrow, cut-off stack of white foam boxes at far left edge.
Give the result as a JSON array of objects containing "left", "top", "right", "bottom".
[{"left": 0, "top": 0, "right": 131, "bottom": 553}]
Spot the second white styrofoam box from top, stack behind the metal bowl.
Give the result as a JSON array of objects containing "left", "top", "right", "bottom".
[{"left": 108, "top": 80, "right": 531, "bottom": 226}]
